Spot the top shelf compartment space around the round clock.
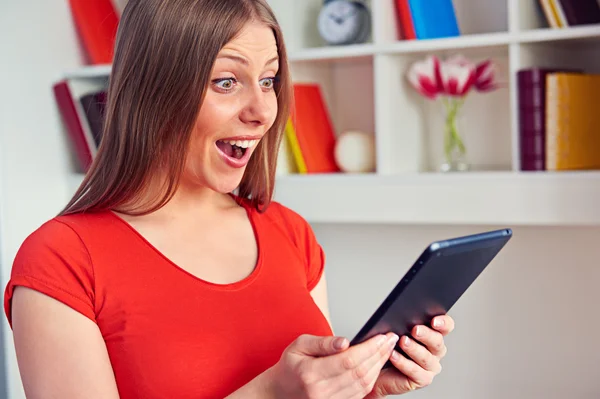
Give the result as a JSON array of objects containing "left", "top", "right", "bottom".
[{"left": 268, "top": 0, "right": 373, "bottom": 54}]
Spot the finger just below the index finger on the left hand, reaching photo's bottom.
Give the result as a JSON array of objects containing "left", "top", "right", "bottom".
[{"left": 341, "top": 333, "right": 398, "bottom": 398}]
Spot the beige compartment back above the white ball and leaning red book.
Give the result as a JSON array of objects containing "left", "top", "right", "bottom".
[{"left": 291, "top": 57, "right": 375, "bottom": 164}]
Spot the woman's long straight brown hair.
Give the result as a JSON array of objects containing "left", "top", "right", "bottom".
[{"left": 60, "top": 0, "right": 292, "bottom": 215}]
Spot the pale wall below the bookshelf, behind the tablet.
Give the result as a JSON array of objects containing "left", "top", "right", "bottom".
[{"left": 315, "top": 225, "right": 600, "bottom": 399}]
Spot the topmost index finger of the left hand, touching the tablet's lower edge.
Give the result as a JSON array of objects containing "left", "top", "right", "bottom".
[{"left": 322, "top": 334, "right": 388, "bottom": 377}]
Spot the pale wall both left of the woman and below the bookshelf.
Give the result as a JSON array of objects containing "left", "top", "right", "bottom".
[{"left": 0, "top": 0, "right": 600, "bottom": 399}]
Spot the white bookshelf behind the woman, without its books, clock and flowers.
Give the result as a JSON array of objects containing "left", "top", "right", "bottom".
[{"left": 65, "top": 0, "right": 600, "bottom": 225}]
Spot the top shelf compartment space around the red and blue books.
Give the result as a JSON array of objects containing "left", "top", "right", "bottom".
[{"left": 374, "top": 0, "right": 508, "bottom": 44}]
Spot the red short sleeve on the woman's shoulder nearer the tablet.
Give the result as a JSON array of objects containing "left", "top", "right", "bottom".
[{"left": 271, "top": 202, "right": 325, "bottom": 291}]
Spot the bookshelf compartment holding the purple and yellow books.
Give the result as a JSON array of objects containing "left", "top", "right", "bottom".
[{"left": 514, "top": 40, "right": 600, "bottom": 173}]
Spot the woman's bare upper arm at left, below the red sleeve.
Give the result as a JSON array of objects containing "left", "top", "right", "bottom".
[{"left": 12, "top": 287, "right": 119, "bottom": 399}]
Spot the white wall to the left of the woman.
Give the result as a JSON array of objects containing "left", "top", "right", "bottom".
[{"left": 0, "top": 0, "right": 80, "bottom": 399}]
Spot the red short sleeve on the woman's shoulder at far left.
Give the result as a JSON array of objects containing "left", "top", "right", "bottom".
[{"left": 4, "top": 219, "right": 95, "bottom": 327}]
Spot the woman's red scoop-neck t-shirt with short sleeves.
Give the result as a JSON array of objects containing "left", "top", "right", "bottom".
[{"left": 4, "top": 198, "right": 332, "bottom": 399}]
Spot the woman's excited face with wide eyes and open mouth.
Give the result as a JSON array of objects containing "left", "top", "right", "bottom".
[{"left": 184, "top": 22, "right": 278, "bottom": 193}]
